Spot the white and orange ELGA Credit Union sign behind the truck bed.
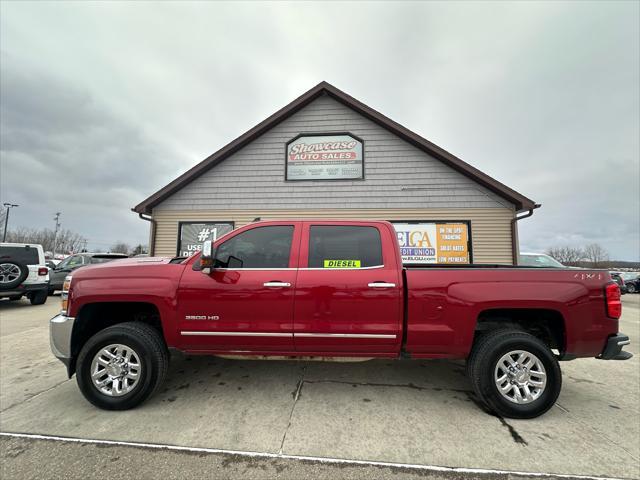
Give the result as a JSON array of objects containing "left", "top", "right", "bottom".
[{"left": 393, "top": 223, "right": 471, "bottom": 264}]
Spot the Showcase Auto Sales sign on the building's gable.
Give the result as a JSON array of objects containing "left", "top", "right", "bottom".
[{"left": 286, "top": 134, "right": 364, "bottom": 180}]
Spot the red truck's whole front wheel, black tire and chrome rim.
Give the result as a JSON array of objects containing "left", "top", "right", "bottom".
[{"left": 76, "top": 322, "right": 169, "bottom": 410}]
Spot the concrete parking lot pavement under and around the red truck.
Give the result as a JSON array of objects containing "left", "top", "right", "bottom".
[{"left": 0, "top": 295, "right": 640, "bottom": 478}]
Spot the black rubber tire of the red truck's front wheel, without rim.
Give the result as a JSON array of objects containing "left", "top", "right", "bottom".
[{"left": 76, "top": 322, "right": 169, "bottom": 410}]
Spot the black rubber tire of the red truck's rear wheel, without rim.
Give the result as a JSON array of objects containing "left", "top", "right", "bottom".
[{"left": 467, "top": 330, "right": 562, "bottom": 418}]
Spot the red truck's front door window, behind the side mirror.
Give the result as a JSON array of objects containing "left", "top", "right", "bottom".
[{"left": 215, "top": 225, "right": 293, "bottom": 268}]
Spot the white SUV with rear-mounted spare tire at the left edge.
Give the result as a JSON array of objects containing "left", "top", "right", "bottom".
[{"left": 0, "top": 243, "right": 49, "bottom": 305}]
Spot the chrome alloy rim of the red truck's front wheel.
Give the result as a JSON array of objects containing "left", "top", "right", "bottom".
[{"left": 91, "top": 343, "right": 142, "bottom": 397}]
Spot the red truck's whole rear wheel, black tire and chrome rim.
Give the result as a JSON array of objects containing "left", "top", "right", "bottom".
[{"left": 467, "top": 330, "right": 562, "bottom": 418}]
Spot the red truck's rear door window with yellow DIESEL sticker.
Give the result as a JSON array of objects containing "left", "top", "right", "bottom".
[{"left": 309, "top": 225, "right": 382, "bottom": 268}]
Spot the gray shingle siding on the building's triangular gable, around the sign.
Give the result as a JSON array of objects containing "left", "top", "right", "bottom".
[{"left": 155, "top": 95, "right": 513, "bottom": 210}]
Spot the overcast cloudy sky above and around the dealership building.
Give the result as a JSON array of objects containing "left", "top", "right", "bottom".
[{"left": 0, "top": 1, "right": 640, "bottom": 260}]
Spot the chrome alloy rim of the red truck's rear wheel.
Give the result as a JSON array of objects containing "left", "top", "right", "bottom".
[{"left": 494, "top": 350, "right": 547, "bottom": 404}]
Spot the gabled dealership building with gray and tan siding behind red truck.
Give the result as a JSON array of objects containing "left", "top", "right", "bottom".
[{"left": 133, "top": 82, "right": 539, "bottom": 264}]
